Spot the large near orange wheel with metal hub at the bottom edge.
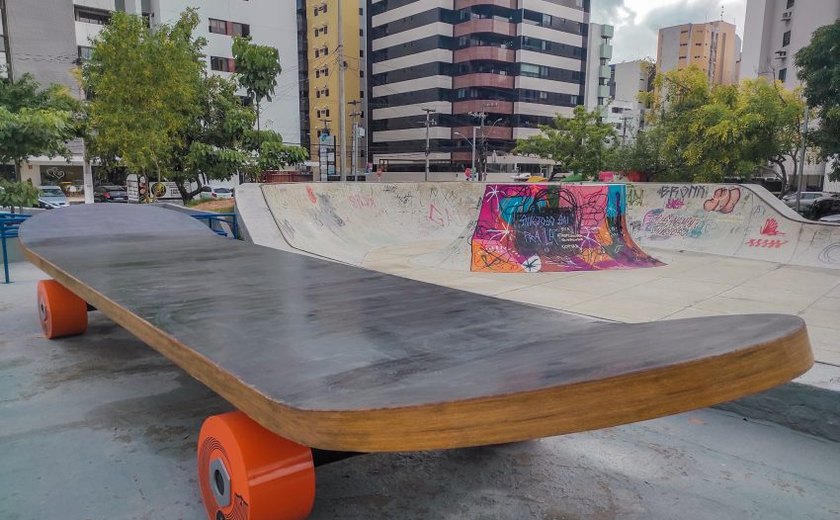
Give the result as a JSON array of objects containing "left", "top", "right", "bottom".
[{"left": 198, "top": 412, "right": 315, "bottom": 520}]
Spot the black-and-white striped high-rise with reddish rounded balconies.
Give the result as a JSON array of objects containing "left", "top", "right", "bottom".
[{"left": 368, "top": 0, "right": 589, "bottom": 177}]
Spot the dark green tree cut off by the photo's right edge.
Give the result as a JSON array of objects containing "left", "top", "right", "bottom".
[{"left": 796, "top": 20, "right": 840, "bottom": 181}]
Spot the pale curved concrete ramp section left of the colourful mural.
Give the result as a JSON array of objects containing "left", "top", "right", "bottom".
[{"left": 261, "top": 182, "right": 484, "bottom": 264}]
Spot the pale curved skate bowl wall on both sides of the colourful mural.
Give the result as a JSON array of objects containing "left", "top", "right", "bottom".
[{"left": 237, "top": 182, "right": 840, "bottom": 271}]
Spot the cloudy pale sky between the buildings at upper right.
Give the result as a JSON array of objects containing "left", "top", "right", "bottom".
[{"left": 591, "top": 0, "right": 747, "bottom": 63}]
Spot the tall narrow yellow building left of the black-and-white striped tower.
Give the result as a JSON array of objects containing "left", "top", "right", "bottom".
[{"left": 306, "top": 0, "right": 365, "bottom": 177}]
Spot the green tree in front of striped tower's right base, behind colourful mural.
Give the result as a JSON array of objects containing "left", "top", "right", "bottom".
[{"left": 514, "top": 105, "right": 616, "bottom": 179}]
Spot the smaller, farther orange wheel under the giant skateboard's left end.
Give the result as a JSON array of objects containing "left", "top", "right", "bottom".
[{"left": 38, "top": 280, "right": 87, "bottom": 339}]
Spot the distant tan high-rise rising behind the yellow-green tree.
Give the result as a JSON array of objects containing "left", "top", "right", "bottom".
[{"left": 656, "top": 20, "right": 741, "bottom": 85}]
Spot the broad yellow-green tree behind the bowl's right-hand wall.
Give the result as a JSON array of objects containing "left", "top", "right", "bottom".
[{"left": 647, "top": 66, "right": 804, "bottom": 183}]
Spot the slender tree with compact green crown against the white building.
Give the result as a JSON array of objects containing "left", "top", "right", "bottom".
[{"left": 232, "top": 36, "right": 282, "bottom": 136}]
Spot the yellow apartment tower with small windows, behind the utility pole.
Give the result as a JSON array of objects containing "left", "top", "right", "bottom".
[{"left": 298, "top": 0, "right": 367, "bottom": 180}]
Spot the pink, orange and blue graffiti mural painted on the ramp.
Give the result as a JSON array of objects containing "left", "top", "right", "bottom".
[{"left": 471, "top": 184, "right": 663, "bottom": 273}]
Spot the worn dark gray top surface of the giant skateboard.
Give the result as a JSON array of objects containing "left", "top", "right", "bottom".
[{"left": 20, "top": 205, "right": 803, "bottom": 411}]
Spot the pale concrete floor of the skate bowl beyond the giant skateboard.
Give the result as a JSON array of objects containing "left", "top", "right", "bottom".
[{"left": 362, "top": 241, "right": 840, "bottom": 366}]
